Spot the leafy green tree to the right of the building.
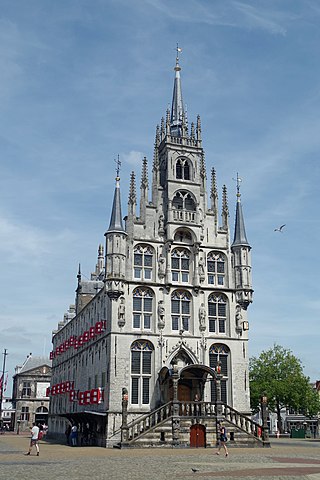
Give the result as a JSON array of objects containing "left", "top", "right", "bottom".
[{"left": 249, "top": 344, "right": 320, "bottom": 432}]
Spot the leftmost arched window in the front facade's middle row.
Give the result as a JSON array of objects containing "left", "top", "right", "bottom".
[{"left": 132, "top": 288, "right": 153, "bottom": 330}]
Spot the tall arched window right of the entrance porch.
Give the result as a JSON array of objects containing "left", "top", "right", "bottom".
[{"left": 209, "top": 343, "right": 230, "bottom": 403}]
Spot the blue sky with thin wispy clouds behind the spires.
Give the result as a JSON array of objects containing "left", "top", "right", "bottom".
[{"left": 0, "top": 0, "right": 320, "bottom": 390}]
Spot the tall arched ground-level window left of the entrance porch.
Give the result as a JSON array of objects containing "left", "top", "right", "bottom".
[{"left": 131, "top": 340, "right": 154, "bottom": 405}]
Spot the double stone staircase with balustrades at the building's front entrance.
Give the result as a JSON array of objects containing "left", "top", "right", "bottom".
[{"left": 118, "top": 401, "right": 264, "bottom": 448}]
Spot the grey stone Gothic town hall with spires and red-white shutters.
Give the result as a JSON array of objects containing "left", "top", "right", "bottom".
[{"left": 48, "top": 51, "right": 256, "bottom": 446}]
